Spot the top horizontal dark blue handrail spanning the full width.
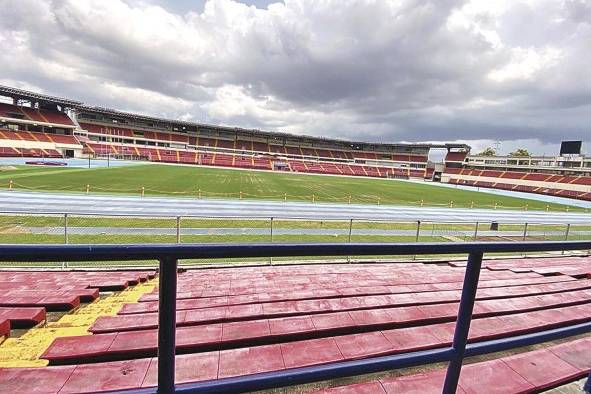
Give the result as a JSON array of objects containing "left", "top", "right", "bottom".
[{"left": 0, "top": 241, "right": 591, "bottom": 262}]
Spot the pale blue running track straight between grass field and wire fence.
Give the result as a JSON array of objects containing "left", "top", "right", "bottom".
[{"left": 0, "top": 190, "right": 591, "bottom": 224}]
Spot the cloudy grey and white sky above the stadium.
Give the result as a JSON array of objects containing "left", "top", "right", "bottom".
[{"left": 0, "top": 0, "right": 591, "bottom": 154}]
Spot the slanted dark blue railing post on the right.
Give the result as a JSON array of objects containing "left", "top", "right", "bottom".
[{"left": 443, "top": 252, "right": 483, "bottom": 394}]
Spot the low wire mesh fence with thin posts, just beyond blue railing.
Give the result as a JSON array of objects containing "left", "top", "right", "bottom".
[{"left": 0, "top": 213, "right": 591, "bottom": 267}]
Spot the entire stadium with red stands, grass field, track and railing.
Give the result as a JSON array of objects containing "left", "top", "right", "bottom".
[{"left": 0, "top": 81, "right": 591, "bottom": 393}]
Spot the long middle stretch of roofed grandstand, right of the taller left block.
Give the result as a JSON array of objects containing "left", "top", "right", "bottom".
[{"left": 76, "top": 107, "right": 446, "bottom": 178}]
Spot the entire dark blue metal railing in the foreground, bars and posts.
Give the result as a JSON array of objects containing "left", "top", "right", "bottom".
[{"left": 0, "top": 241, "right": 591, "bottom": 394}]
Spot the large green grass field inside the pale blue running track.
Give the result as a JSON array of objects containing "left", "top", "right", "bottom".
[{"left": 0, "top": 165, "right": 583, "bottom": 211}]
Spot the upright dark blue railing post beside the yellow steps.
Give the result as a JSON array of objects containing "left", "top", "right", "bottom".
[{"left": 158, "top": 257, "right": 178, "bottom": 394}]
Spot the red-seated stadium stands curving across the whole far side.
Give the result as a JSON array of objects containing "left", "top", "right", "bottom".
[{"left": 0, "top": 86, "right": 591, "bottom": 201}]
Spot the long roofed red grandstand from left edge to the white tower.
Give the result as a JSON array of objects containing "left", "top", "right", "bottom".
[{"left": 0, "top": 87, "right": 468, "bottom": 179}]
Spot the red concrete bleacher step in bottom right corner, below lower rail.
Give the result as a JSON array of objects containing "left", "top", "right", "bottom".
[{"left": 314, "top": 338, "right": 591, "bottom": 394}]
